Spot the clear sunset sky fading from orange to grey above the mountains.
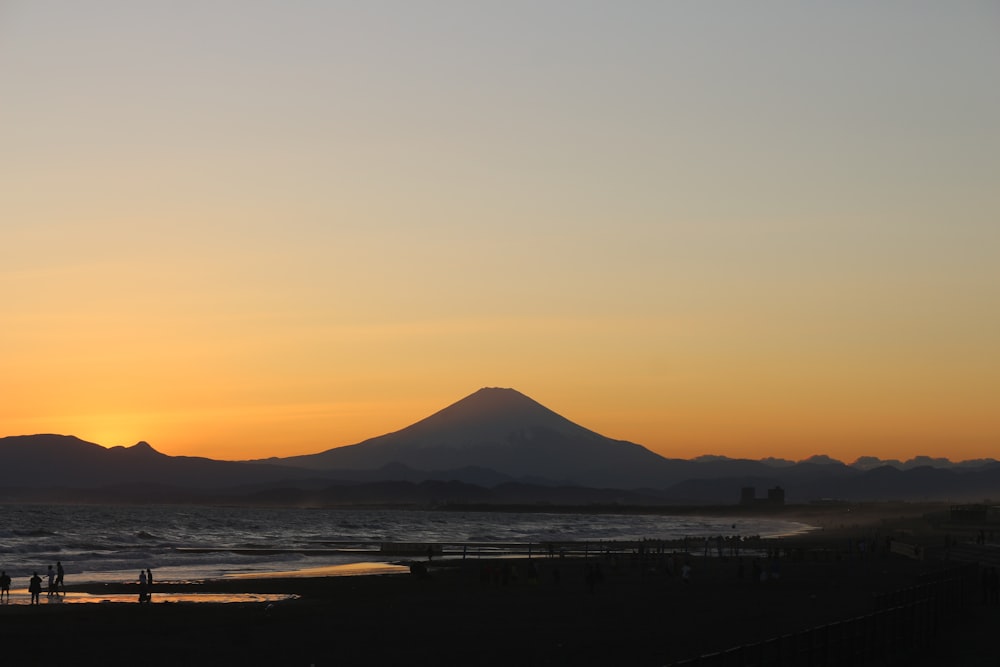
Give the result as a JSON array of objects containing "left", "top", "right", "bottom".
[{"left": 0, "top": 0, "right": 1000, "bottom": 461}]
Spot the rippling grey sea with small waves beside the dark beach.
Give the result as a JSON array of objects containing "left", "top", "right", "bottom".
[{"left": 0, "top": 504, "right": 809, "bottom": 586}]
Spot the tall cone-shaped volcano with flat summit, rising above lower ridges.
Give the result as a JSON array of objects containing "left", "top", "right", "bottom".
[{"left": 267, "top": 388, "right": 668, "bottom": 488}]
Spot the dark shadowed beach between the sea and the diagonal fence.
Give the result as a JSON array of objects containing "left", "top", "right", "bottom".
[{"left": 0, "top": 506, "right": 1000, "bottom": 667}]
